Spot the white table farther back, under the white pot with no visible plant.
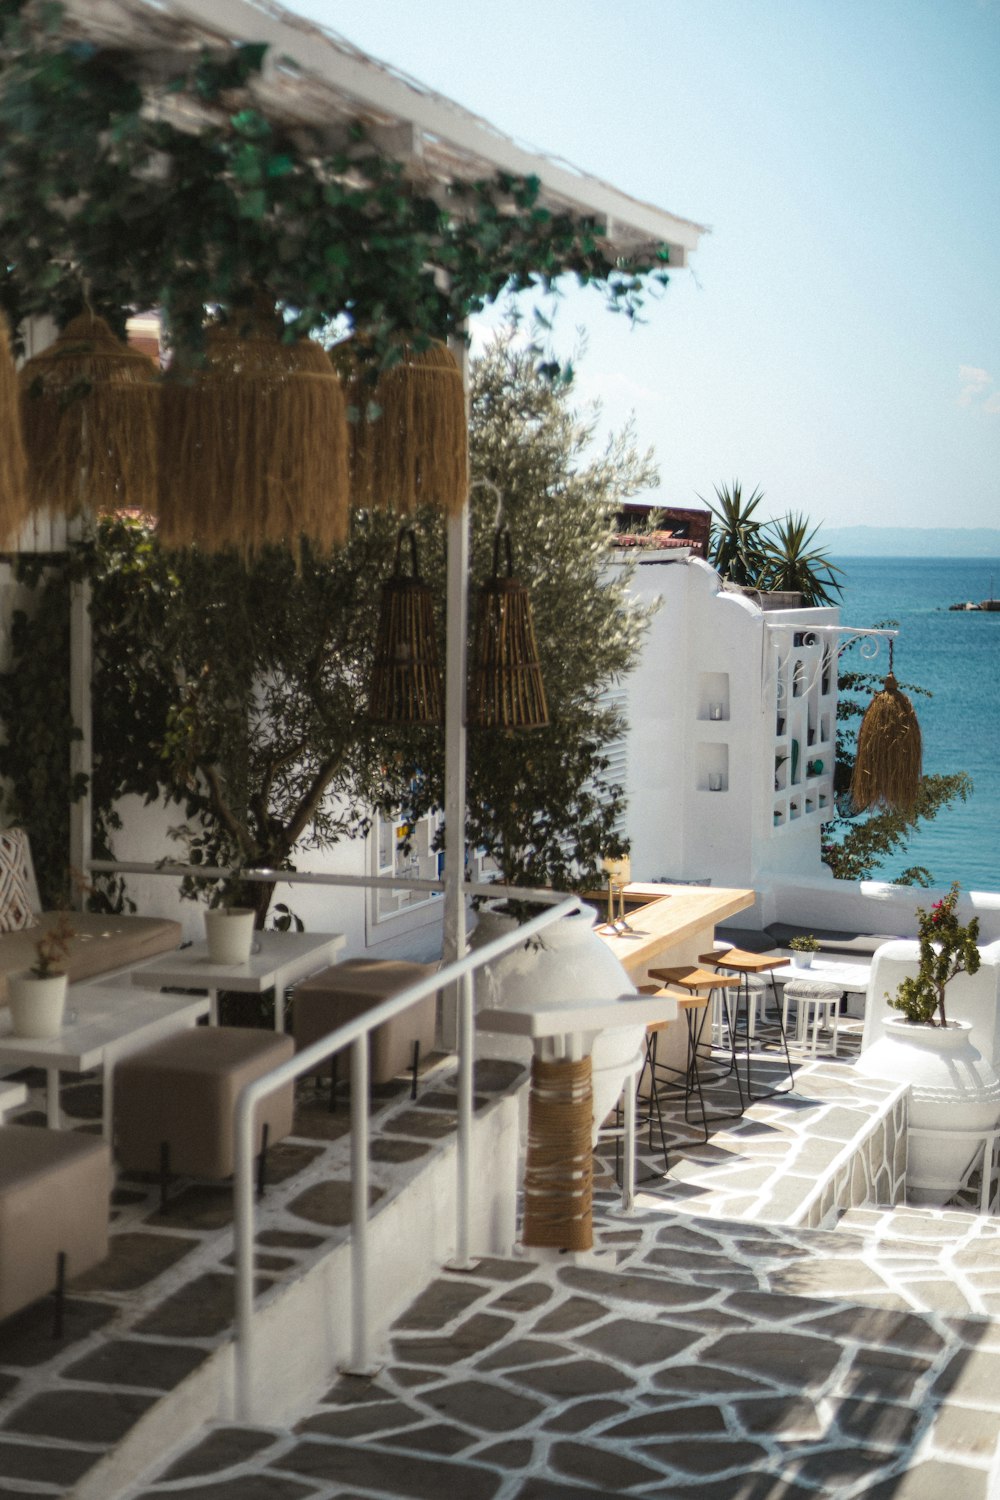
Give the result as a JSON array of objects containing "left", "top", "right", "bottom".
[{"left": 132, "top": 932, "right": 346, "bottom": 1031}]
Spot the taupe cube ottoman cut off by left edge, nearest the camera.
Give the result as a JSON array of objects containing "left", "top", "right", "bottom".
[{"left": 0, "top": 1125, "right": 111, "bottom": 1319}]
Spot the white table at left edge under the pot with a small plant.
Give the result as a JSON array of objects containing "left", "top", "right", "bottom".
[{"left": 0, "top": 984, "right": 208, "bottom": 1140}]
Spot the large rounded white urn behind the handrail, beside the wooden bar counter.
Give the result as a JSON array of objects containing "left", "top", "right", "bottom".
[{"left": 469, "top": 909, "right": 646, "bottom": 1143}]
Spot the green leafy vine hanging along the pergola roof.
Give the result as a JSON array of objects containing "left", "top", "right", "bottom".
[{"left": 0, "top": 0, "right": 667, "bottom": 363}]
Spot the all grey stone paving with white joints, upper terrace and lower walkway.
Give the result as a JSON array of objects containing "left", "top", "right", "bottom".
[{"left": 0, "top": 1014, "right": 1000, "bottom": 1500}]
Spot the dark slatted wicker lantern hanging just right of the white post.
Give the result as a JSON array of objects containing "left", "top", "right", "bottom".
[{"left": 468, "top": 527, "right": 549, "bottom": 729}]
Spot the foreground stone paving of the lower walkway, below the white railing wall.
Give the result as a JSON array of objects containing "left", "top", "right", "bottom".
[{"left": 111, "top": 1194, "right": 1000, "bottom": 1500}]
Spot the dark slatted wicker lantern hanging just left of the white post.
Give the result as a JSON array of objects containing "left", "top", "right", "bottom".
[{"left": 369, "top": 527, "right": 444, "bottom": 725}]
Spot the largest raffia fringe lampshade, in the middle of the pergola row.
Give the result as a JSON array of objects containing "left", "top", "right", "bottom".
[{"left": 159, "top": 308, "right": 349, "bottom": 555}]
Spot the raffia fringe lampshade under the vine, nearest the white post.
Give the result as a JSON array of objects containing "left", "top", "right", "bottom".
[{"left": 333, "top": 341, "right": 469, "bottom": 515}]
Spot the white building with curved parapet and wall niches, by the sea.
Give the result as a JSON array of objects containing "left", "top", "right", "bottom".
[{"left": 614, "top": 552, "right": 838, "bottom": 887}]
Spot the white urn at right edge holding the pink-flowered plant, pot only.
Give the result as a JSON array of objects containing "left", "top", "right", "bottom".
[{"left": 855, "top": 1017, "right": 1000, "bottom": 1203}]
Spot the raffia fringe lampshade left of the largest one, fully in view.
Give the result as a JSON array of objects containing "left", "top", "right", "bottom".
[{"left": 19, "top": 312, "right": 157, "bottom": 516}]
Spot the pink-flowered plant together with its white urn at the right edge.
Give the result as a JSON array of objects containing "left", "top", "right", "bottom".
[{"left": 856, "top": 882, "right": 1000, "bottom": 1203}]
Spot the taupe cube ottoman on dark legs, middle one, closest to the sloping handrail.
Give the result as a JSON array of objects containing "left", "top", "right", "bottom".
[{"left": 114, "top": 1026, "right": 295, "bottom": 1193}]
